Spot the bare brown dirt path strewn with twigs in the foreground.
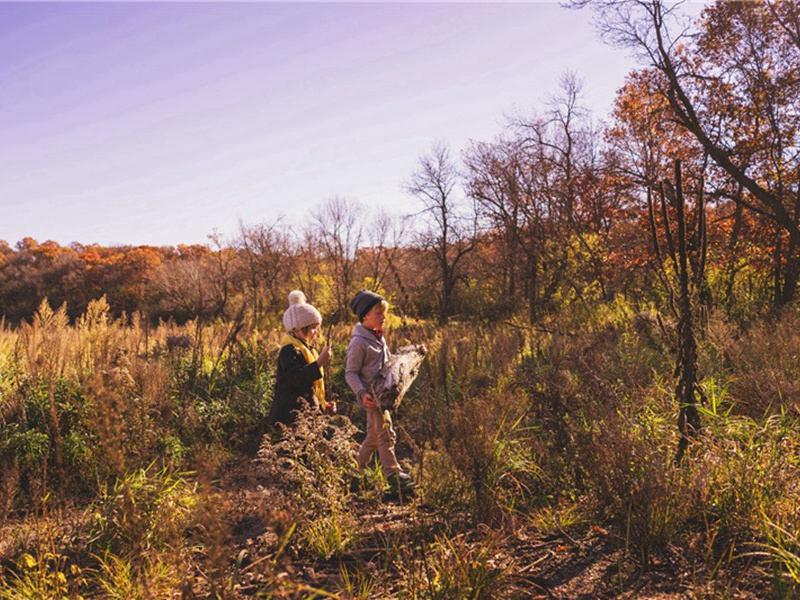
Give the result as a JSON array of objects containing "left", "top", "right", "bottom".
[{"left": 206, "top": 460, "right": 767, "bottom": 600}]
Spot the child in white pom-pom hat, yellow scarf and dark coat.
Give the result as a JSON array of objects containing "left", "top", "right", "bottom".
[{"left": 267, "top": 290, "right": 336, "bottom": 427}]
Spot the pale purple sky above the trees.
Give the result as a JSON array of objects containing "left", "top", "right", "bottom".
[{"left": 0, "top": 1, "right": 676, "bottom": 246}]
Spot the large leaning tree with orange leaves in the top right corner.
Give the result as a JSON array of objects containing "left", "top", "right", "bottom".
[{"left": 576, "top": 0, "right": 800, "bottom": 307}]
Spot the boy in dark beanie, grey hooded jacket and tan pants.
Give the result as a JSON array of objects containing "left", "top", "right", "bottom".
[{"left": 345, "top": 290, "right": 413, "bottom": 495}]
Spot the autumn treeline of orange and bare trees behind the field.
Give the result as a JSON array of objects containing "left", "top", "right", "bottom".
[{"left": 0, "top": 0, "right": 800, "bottom": 322}]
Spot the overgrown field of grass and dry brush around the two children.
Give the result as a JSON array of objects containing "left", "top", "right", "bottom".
[{"left": 0, "top": 300, "right": 800, "bottom": 599}]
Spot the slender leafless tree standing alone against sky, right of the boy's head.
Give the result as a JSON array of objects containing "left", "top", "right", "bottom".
[{"left": 403, "top": 143, "right": 477, "bottom": 324}]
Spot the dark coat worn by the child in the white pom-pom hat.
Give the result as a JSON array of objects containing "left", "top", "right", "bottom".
[{"left": 267, "top": 344, "right": 322, "bottom": 427}]
